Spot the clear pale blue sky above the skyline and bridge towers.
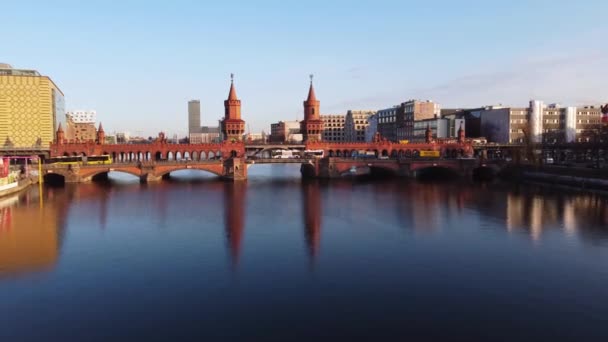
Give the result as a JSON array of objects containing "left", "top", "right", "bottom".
[{"left": 0, "top": 0, "right": 608, "bottom": 136}]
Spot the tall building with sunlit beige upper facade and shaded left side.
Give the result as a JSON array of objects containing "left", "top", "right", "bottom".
[{"left": 395, "top": 100, "right": 441, "bottom": 140}]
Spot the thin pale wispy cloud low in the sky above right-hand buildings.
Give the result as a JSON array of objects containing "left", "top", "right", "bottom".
[{"left": 413, "top": 49, "right": 608, "bottom": 106}]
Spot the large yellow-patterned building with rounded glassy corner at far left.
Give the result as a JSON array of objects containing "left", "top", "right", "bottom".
[{"left": 0, "top": 64, "right": 65, "bottom": 147}]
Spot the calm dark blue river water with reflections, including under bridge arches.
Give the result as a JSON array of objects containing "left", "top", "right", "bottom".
[{"left": 0, "top": 165, "right": 608, "bottom": 341}]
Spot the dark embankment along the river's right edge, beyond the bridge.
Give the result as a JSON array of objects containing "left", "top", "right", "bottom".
[{"left": 499, "top": 165, "right": 608, "bottom": 192}]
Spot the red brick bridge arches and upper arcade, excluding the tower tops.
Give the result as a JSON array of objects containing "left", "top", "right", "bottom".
[{"left": 44, "top": 139, "right": 479, "bottom": 182}]
